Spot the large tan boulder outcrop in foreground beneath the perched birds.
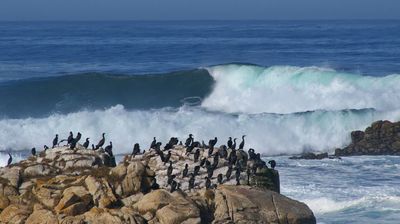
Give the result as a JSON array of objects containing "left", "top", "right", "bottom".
[{"left": 0, "top": 145, "right": 315, "bottom": 224}]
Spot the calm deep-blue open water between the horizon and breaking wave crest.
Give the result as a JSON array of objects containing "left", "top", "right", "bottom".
[{"left": 0, "top": 21, "right": 400, "bottom": 80}]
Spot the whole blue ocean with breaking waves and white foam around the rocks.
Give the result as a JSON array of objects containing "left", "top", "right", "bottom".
[{"left": 0, "top": 20, "right": 400, "bottom": 223}]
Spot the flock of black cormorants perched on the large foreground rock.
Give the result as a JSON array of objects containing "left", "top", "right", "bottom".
[{"left": 7, "top": 131, "right": 276, "bottom": 192}]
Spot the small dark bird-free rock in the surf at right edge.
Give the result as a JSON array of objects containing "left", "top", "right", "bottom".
[{"left": 335, "top": 121, "right": 400, "bottom": 156}]
